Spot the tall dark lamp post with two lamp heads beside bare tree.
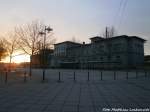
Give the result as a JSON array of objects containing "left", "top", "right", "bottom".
[{"left": 39, "top": 26, "right": 53, "bottom": 81}]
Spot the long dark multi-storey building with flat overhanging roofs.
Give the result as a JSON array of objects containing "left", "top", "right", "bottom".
[{"left": 50, "top": 35, "right": 145, "bottom": 69}]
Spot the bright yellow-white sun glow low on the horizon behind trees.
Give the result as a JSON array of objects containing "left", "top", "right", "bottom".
[{"left": 12, "top": 55, "right": 30, "bottom": 63}]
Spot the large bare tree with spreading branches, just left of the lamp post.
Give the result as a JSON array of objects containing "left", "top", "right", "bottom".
[{"left": 15, "top": 21, "right": 55, "bottom": 77}]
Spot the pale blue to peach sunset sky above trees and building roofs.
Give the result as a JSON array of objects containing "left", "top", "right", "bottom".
[{"left": 0, "top": 0, "right": 150, "bottom": 57}]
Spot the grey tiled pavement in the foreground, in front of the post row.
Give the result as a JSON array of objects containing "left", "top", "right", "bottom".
[{"left": 0, "top": 78, "right": 150, "bottom": 112}]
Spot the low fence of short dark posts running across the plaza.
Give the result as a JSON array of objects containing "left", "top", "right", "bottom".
[{"left": 0, "top": 69, "right": 150, "bottom": 84}]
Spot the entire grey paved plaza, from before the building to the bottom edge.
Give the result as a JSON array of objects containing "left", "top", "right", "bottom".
[{"left": 0, "top": 70, "right": 150, "bottom": 112}]
